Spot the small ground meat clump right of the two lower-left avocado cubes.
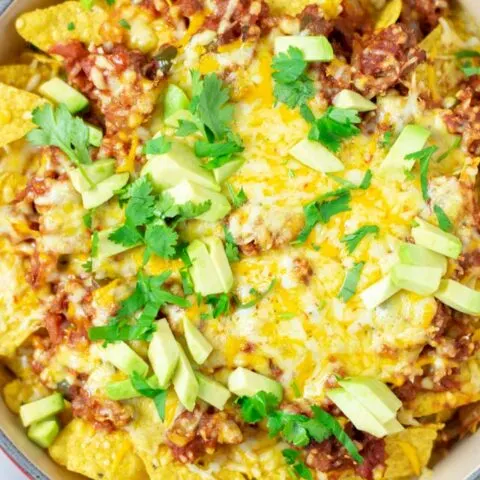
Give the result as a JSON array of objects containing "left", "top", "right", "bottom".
[{"left": 69, "top": 385, "right": 132, "bottom": 431}]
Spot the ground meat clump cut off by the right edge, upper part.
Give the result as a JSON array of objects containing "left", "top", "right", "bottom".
[{"left": 444, "top": 75, "right": 480, "bottom": 155}]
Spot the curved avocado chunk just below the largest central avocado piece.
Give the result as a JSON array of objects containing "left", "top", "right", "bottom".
[{"left": 165, "top": 180, "right": 232, "bottom": 222}]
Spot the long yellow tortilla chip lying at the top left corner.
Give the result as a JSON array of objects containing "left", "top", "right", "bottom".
[{"left": 16, "top": 2, "right": 108, "bottom": 52}]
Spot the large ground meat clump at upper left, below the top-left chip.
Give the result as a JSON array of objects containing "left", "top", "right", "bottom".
[{"left": 50, "top": 41, "right": 163, "bottom": 134}]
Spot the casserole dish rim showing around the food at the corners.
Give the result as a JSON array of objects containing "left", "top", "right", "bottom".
[{"left": 0, "top": 0, "right": 480, "bottom": 480}]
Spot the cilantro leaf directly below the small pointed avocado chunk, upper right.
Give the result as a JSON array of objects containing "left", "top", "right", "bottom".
[{"left": 304, "top": 107, "right": 361, "bottom": 153}]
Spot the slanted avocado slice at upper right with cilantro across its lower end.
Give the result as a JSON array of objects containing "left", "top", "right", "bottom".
[{"left": 381, "top": 125, "right": 430, "bottom": 174}]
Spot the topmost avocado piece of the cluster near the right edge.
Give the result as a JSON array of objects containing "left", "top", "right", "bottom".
[{"left": 412, "top": 218, "right": 462, "bottom": 258}]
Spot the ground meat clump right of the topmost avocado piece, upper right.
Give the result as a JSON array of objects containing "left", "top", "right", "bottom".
[{"left": 352, "top": 24, "right": 426, "bottom": 98}]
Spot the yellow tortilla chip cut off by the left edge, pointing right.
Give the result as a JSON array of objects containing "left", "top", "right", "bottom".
[{"left": 0, "top": 83, "right": 45, "bottom": 147}]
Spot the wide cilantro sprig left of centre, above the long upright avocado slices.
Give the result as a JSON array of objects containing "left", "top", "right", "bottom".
[{"left": 88, "top": 271, "right": 190, "bottom": 344}]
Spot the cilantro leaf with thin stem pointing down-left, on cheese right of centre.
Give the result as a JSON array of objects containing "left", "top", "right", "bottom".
[{"left": 293, "top": 188, "right": 352, "bottom": 244}]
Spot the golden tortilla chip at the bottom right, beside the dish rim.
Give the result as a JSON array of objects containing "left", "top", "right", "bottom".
[{"left": 384, "top": 424, "right": 443, "bottom": 478}]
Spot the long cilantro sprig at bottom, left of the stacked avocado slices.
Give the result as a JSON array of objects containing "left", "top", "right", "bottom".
[{"left": 237, "top": 392, "right": 363, "bottom": 463}]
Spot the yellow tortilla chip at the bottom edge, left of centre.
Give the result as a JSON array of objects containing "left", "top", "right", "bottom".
[{"left": 49, "top": 418, "right": 148, "bottom": 480}]
